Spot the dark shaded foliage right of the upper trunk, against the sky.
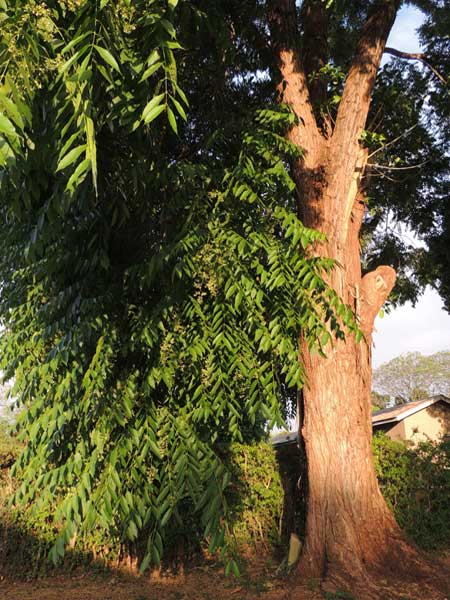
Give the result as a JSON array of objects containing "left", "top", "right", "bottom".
[{"left": 363, "top": 0, "right": 450, "bottom": 308}]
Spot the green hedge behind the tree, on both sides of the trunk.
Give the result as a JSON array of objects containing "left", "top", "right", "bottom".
[{"left": 0, "top": 424, "right": 450, "bottom": 577}]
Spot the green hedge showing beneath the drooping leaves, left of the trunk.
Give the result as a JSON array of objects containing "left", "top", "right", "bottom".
[{"left": 0, "top": 437, "right": 283, "bottom": 575}]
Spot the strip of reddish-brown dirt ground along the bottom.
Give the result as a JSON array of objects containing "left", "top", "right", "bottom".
[{"left": 0, "top": 565, "right": 450, "bottom": 600}]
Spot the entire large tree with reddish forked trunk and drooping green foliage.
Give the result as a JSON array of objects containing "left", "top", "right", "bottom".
[{"left": 1, "top": 0, "right": 448, "bottom": 592}]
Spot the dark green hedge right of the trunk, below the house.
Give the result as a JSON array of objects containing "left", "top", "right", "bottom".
[{"left": 374, "top": 435, "right": 450, "bottom": 549}]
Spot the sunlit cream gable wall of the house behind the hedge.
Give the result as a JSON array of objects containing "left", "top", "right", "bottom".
[{"left": 402, "top": 402, "right": 450, "bottom": 442}]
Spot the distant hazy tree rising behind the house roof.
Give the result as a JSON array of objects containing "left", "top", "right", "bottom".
[{"left": 373, "top": 352, "right": 450, "bottom": 402}]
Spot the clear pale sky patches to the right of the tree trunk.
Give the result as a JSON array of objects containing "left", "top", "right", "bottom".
[{"left": 372, "top": 7, "right": 450, "bottom": 368}]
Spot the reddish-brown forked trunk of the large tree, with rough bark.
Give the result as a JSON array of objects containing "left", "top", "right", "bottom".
[{"left": 268, "top": 0, "right": 408, "bottom": 578}]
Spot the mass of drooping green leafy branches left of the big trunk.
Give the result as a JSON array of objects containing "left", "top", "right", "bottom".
[{"left": 0, "top": 0, "right": 356, "bottom": 568}]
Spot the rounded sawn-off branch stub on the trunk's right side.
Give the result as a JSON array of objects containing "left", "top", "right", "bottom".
[{"left": 360, "top": 266, "right": 396, "bottom": 336}]
